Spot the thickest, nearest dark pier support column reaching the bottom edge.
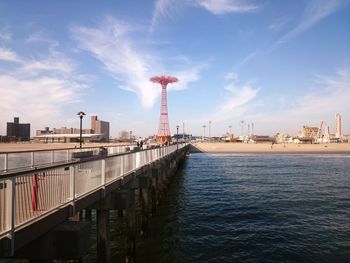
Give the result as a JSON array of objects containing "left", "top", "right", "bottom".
[{"left": 96, "top": 209, "right": 111, "bottom": 263}]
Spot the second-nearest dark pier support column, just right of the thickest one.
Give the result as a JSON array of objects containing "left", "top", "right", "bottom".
[{"left": 125, "top": 189, "right": 136, "bottom": 263}]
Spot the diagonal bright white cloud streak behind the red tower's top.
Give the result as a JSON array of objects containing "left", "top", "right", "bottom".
[{"left": 71, "top": 17, "right": 199, "bottom": 107}]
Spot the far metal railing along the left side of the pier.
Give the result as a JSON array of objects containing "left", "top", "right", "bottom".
[{"left": 0, "top": 145, "right": 127, "bottom": 173}]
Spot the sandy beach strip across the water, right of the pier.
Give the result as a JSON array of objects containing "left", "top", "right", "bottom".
[{"left": 192, "top": 142, "right": 350, "bottom": 154}]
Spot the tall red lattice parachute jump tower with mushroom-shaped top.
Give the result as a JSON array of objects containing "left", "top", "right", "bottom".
[{"left": 150, "top": 76, "right": 178, "bottom": 143}]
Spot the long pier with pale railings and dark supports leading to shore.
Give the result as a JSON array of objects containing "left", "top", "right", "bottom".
[{"left": 0, "top": 144, "right": 189, "bottom": 262}]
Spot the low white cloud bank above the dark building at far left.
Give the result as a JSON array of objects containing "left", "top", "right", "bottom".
[{"left": 0, "top": 74, "right": 85, "bottom": 135}]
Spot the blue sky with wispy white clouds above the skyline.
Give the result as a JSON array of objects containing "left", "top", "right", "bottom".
[{"left": 0, "top": 0, "right": 350, "bottom": 137}]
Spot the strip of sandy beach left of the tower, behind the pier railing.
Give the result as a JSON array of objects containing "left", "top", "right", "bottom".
[{"left": 0, "top": 143, "right": 129, "bottom": 152}]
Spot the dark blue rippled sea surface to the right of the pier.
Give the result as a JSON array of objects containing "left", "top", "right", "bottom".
[{"left": 104, "top": 154, "right": 350, "bottom": 262}]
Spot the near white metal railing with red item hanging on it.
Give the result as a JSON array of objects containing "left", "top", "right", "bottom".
[{"left": 0, "top": 144, "right": 186, "bottom": 248}]
